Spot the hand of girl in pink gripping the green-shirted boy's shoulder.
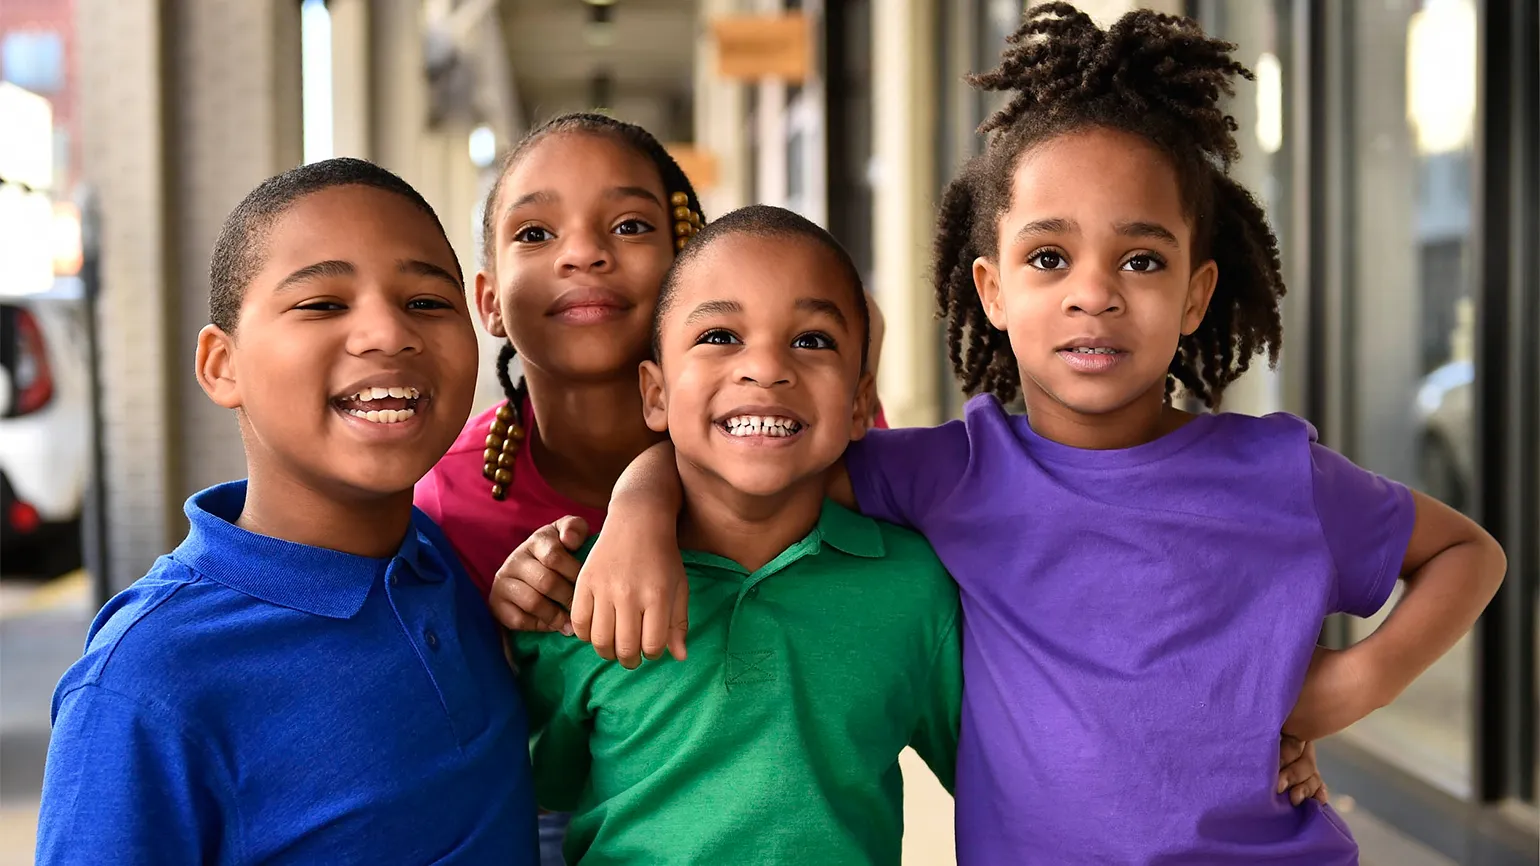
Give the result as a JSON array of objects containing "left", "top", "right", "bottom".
[{"left": 487, "top": 518, "right": 588, "bottom": 635}]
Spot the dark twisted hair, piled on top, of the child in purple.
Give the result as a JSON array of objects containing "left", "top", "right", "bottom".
[{"left": 935, "top": 3, "right": 1284, "bottom": 407}]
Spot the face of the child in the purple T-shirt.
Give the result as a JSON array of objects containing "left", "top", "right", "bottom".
[{"left": 973, "top": 128, "right": 1217, "bottom": 416}]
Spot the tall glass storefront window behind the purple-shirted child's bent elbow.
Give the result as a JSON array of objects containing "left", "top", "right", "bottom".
[{"left": 1346, "top": 0, "right": 1477, "bottom": 797}]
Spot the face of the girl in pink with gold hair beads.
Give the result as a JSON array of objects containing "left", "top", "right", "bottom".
[{"left": 476, "top": 133, "right": 673, "bottom": 382}]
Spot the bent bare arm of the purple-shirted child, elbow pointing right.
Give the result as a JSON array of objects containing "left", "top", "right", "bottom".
[{"left": 1284, "top": 492, "right": 1508, "bottom": 740}]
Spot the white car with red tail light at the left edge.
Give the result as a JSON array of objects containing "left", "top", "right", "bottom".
[{"left": 0, "top": 279, "right": 91, "bottom": 576}]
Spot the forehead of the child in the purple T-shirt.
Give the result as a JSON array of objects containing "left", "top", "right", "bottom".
[{"left": 1009, "top": 128, "right": 1187, "bottom": 231}]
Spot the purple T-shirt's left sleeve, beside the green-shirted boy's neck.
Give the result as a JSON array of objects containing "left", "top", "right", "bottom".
[{"left": 845, "top": 421, "right": 969, "bottom": 533}]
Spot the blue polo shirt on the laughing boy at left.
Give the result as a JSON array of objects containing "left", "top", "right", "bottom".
[{"left": 37, "top": 482, "right": 536, "bottom": 866}]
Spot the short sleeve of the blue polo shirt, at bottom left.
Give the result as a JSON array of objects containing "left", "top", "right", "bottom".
[{"left": 37, "top": 686, "right": 224, "bottom": 864}]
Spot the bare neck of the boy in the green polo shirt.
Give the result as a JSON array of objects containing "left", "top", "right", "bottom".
[{"left": 679, "top": 458, "right": 825, "bottom": 572}]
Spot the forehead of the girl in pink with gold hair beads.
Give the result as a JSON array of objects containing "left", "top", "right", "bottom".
[{"left": 502, "top": 133, "right": 668, "bottom": 202}]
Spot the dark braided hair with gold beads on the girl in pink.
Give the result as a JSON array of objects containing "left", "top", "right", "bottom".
[{"left": 480, "top": 112, "right": 705, "bottom": 425}]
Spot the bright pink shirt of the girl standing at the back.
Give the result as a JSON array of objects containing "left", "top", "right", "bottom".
[{"left": 414, "top": 401, "right": 604, "bottom": 596}]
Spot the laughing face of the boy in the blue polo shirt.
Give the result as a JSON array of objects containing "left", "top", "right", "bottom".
[{"left": 197, "top": 185, "right": 477, "bottom": 501}]
